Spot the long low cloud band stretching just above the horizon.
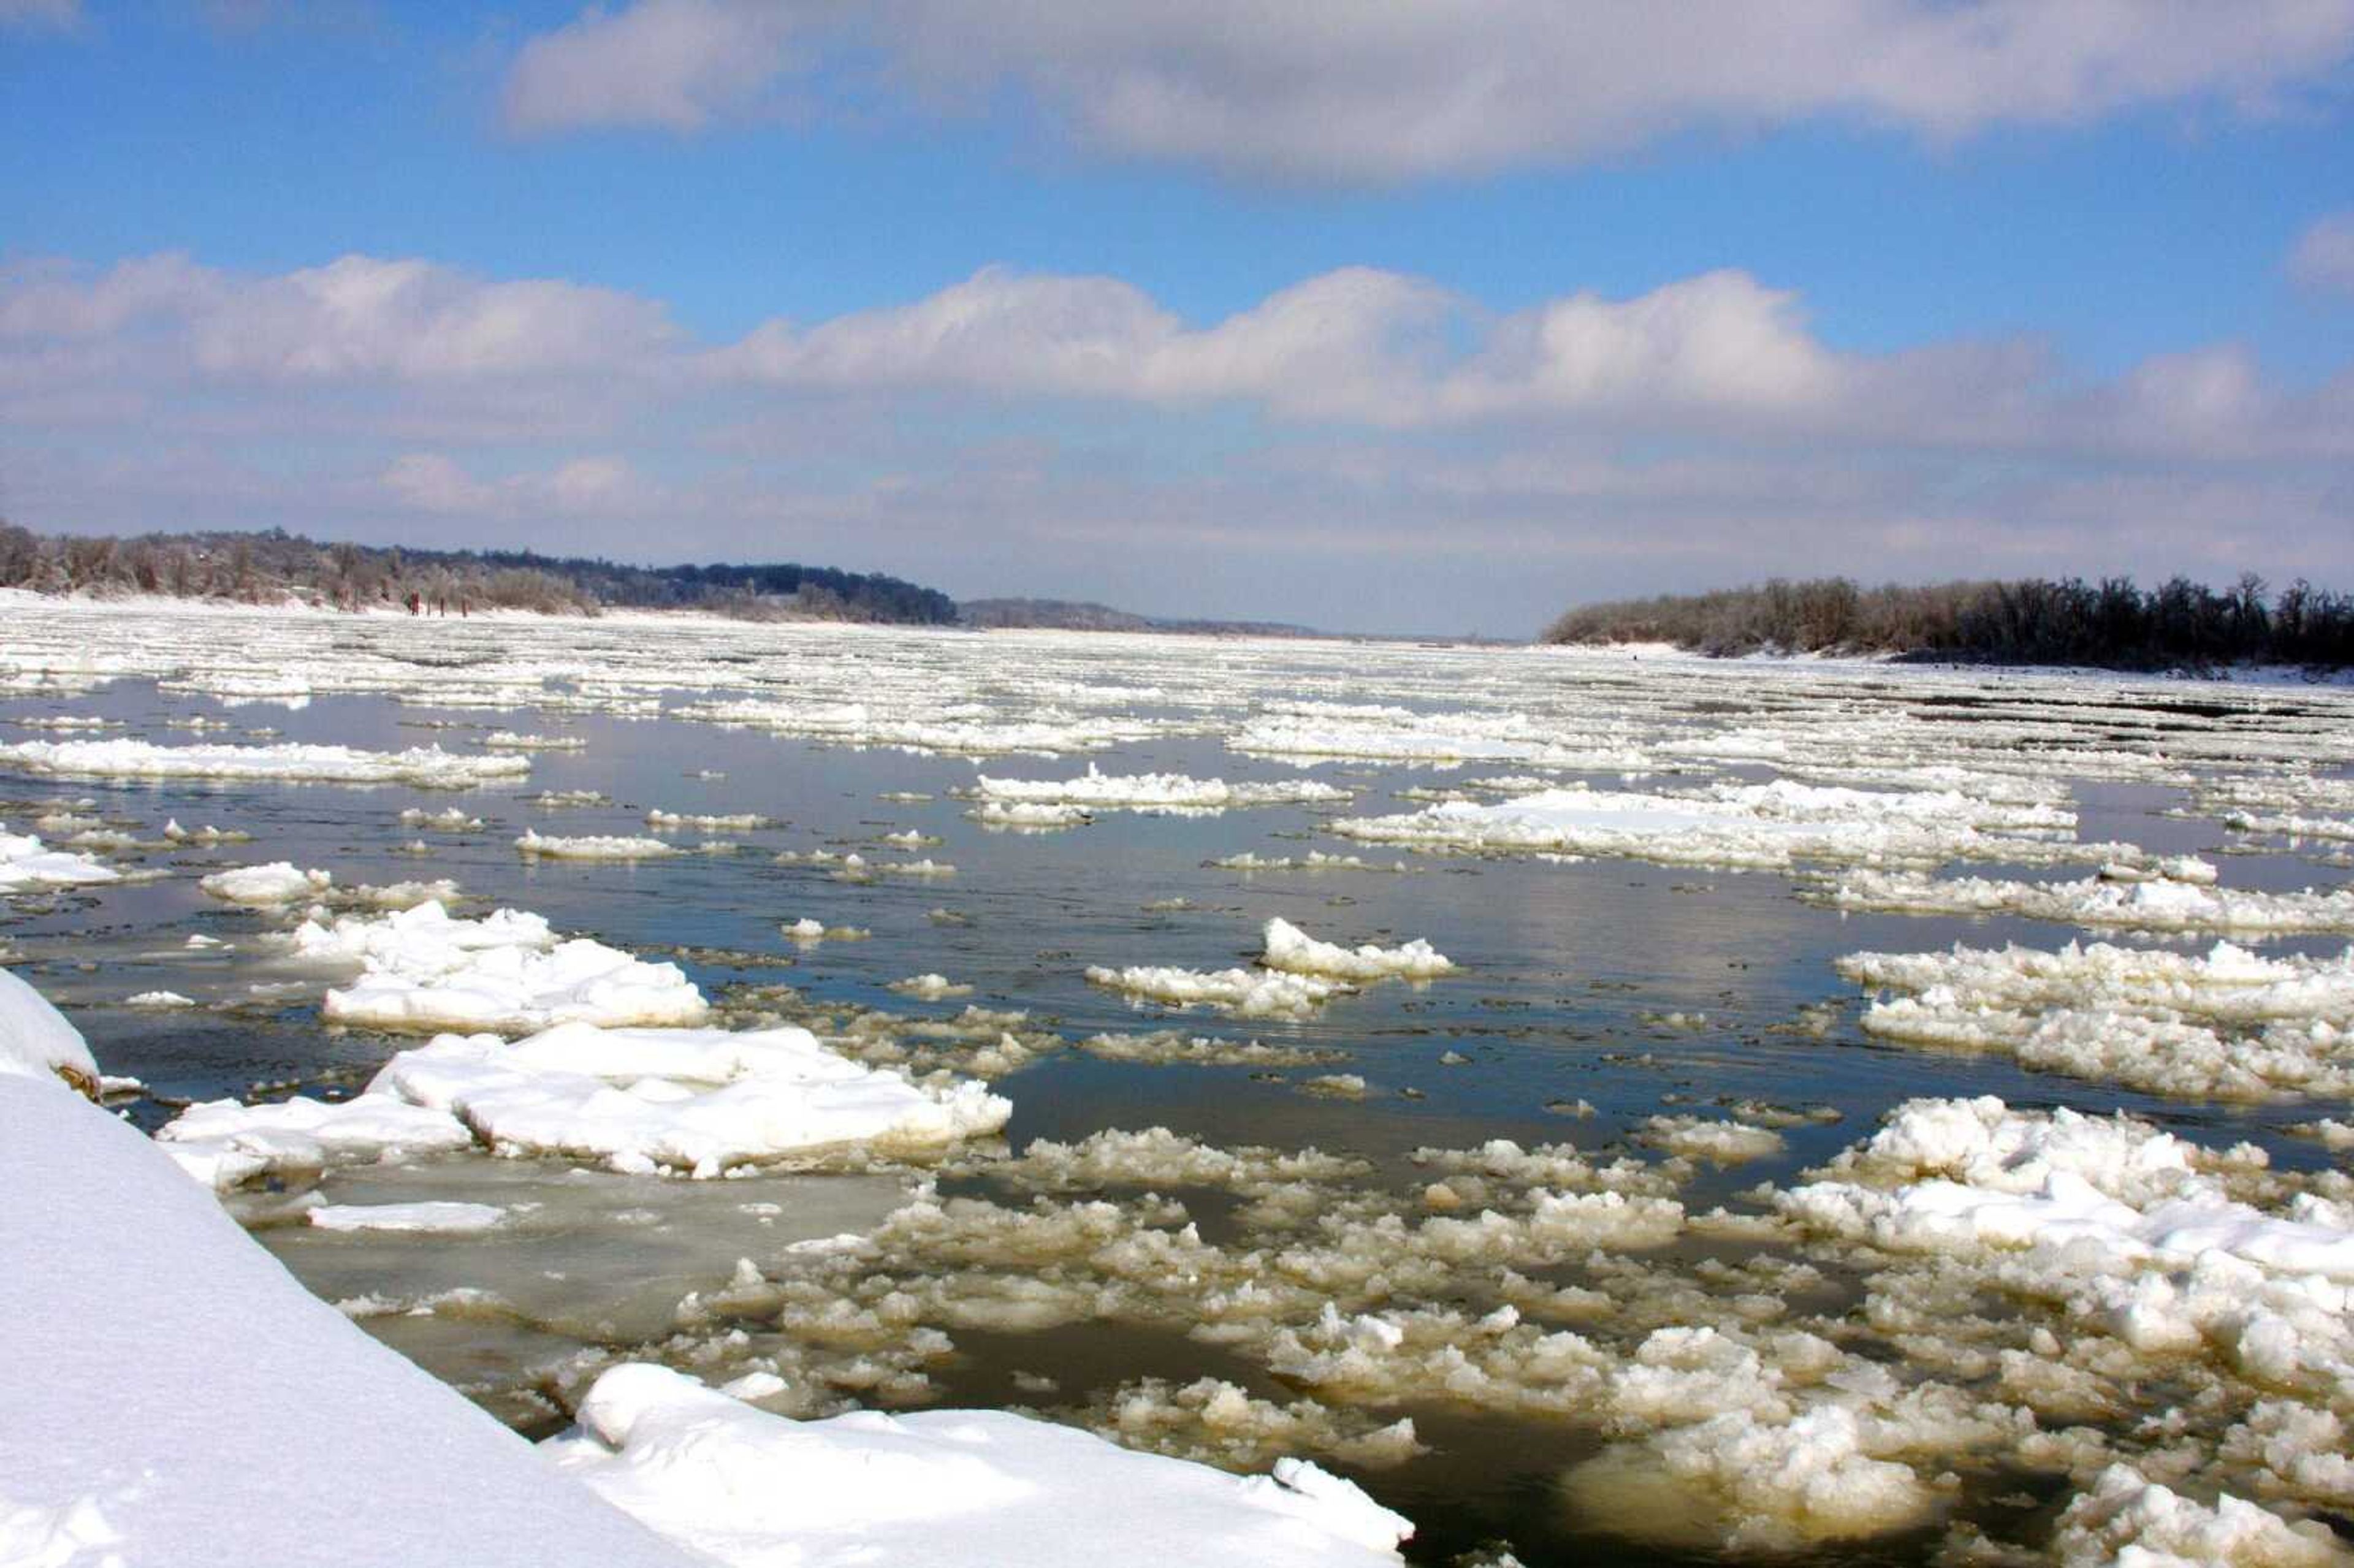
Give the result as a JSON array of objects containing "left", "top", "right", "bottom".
[{"left": 0, "top": 254, "right": 2354, "bottom": 631}]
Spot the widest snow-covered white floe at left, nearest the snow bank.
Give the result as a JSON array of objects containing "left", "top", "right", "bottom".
[{"left": 158, "top": 1024, "right": 1012, "bottom": 1191}]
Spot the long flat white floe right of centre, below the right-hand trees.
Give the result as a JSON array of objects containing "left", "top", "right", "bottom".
[{"left": 1330, "top": 779, "right": 2124, "bottom": 869}]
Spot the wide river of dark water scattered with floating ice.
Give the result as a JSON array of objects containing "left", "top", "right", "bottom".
[{"left": 0, "top": 598, "right": 2354, "bottom": 1566}]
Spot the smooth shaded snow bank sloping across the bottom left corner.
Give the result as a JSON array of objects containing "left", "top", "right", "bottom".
[{"left": 0, "top": 1035, "right": 690, "bottom": 1568}]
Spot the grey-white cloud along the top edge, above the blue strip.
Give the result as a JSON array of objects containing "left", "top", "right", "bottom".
[{"left": 492, "top": 0, "right": 2354, "bottom": 181}]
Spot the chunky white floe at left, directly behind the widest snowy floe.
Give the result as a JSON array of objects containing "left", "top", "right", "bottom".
[{"left": 278, "top": 899, "right": 709, "bottom": 1033}]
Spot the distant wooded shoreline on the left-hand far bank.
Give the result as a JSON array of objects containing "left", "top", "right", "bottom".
[{"left": 0, "top": 520, "right": 956, "bottom": 624}]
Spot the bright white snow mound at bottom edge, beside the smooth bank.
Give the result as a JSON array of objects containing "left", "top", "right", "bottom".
[{"left": 541, "top": 1363, "right": 1412, "bottom": 1568}]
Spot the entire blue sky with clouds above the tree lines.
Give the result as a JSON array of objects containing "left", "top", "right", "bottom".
[{"left": 0, "top": 0, "right": 2354, "bottom": 633}]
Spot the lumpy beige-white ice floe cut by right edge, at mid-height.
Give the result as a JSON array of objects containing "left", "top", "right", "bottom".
[{"left": 1838, "top": 942, "right": 2354, "bottom": 1100}]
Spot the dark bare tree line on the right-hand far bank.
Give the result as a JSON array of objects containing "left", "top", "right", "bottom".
[{"left": 1542, "top": 572, "right": 2354, "bottom": 669}]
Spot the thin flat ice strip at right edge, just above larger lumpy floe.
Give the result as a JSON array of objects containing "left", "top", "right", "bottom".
[{"left": 1827, "top": 871, "right": 2354, "bottom": 939}]
